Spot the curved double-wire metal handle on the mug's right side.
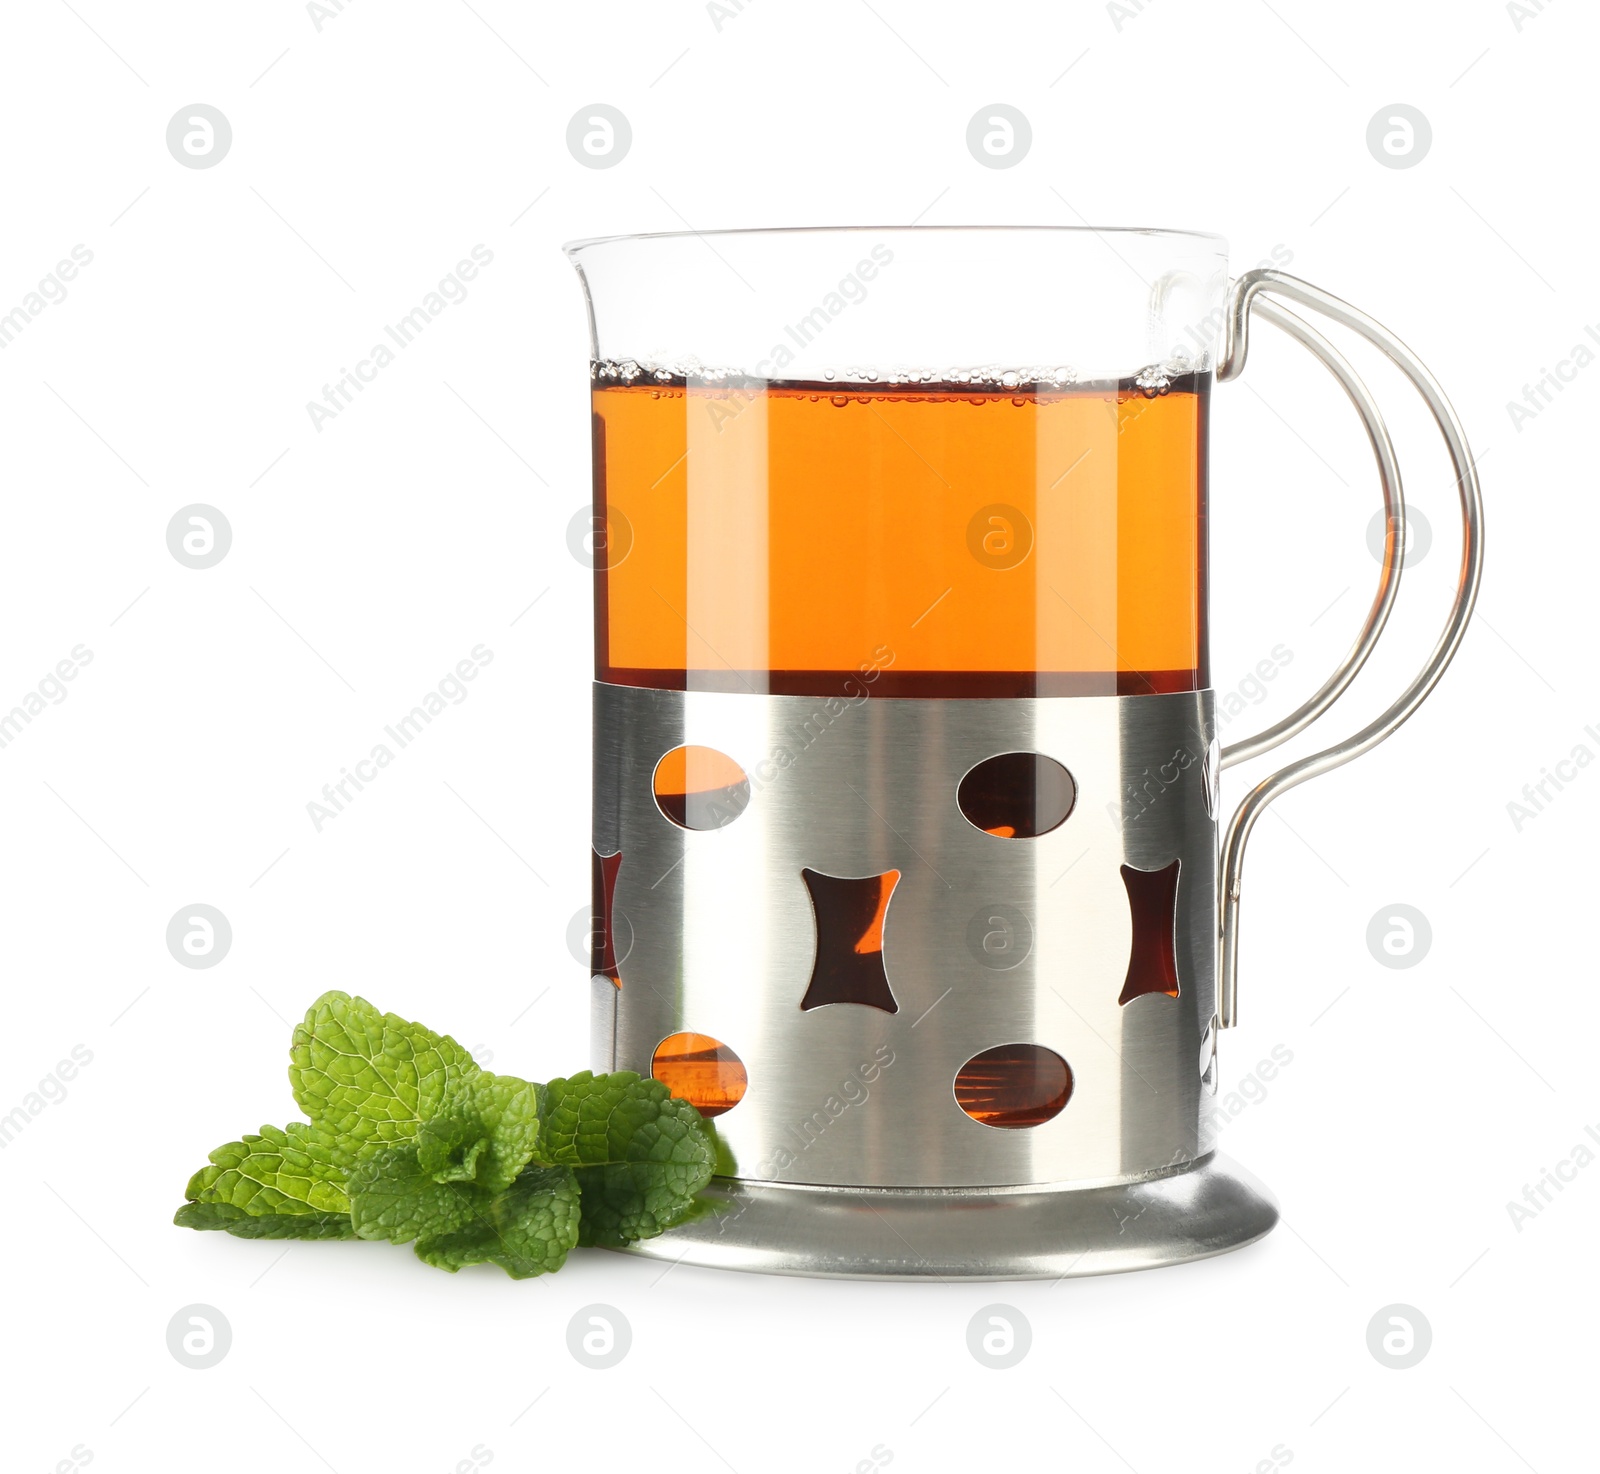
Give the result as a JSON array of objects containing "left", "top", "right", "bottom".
[{"left": 1216, "top": 270, "right": 1483, "bottom": 1029}]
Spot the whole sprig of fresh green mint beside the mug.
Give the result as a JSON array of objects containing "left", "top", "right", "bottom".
[{"left": 173, "top": 992, "right": 717, "bottom": 1279}]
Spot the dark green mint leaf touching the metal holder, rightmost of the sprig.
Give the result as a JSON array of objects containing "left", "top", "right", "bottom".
[{"left": 538, "top": 1071, "right": 717, "bottom": 1248}]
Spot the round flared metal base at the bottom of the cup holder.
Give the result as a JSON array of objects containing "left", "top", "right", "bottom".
[{"left": 611, "top": 1152, "right": 1278, "bottom": 1280}]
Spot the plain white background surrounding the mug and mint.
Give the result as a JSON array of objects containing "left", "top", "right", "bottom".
[{"left": 0, "top": 0, "right": 1600, "bottom": 1474}]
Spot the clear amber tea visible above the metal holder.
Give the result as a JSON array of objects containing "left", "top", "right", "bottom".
[{"left": 594, "top": 365, "right": 1210, "bottom": 696}]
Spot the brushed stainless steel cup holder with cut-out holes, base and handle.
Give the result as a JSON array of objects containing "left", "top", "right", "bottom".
[{"left": 592, "top": 270, "right": 1482, "bottom": 1279}]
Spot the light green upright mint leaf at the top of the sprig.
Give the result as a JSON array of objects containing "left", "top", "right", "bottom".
[{"left": 290, "top": 992, "right": 478, "bottom": 1154}]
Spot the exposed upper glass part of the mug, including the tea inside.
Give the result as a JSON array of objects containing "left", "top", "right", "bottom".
[{"left": 573, "top": 229, "right": 1227, "bottom": 696}]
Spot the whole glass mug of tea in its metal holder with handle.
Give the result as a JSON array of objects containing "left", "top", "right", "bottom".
[{"left": 568, "top": 227, "right": 1482, "bottom": 1272}]
